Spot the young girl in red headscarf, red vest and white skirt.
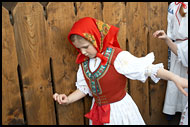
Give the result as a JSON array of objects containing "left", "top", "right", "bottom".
[{"left": 53, "top": 17, "right": 187, "bottom": 125}]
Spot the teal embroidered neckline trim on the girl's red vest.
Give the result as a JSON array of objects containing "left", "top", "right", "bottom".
[{"left": 82, "top": 48, "right": 113, "bottom": 96}]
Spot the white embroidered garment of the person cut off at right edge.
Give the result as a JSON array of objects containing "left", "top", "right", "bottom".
[{"left": 163, "top": 2, "right": 188, "bottom": 115}]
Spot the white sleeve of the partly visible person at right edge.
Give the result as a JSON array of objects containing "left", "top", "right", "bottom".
[{"left": 177, "top": 40, "right": 188, "bottom": 67}]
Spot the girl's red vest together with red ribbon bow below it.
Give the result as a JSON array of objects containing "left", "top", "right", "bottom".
[{"left": 82, "top": 47, "right": 127, "bottom": 125}]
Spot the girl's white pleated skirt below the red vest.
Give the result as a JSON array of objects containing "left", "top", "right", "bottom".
[{"left": 89, "top": 93, "right": 145, "bottom": 125}]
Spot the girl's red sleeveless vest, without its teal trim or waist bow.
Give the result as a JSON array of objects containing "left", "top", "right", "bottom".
[{"left": 81, "top": 47, "right": 127, "bottom": 105}]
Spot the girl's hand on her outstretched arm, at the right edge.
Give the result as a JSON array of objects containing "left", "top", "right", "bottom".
[{"left": 174, "top": 76, "right": 188, "bottom": 96}]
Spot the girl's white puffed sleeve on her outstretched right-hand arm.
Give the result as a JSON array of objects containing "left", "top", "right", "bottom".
[{"left": 114, "top": 51, "right": 163, "bottom": 83}]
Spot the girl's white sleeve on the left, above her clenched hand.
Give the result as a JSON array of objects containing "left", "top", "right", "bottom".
[{"left": 75, "top": 64, "right": 92, "bottom": 96}]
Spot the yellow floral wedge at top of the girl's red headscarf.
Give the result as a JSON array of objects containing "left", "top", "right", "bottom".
[{"left": 96, "top": 19, "right": 111, "bottom": 52}]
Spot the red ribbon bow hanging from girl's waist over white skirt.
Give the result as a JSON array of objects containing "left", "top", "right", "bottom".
[{"left": 85, "top": 103, "right": 110, "bottom": 125}]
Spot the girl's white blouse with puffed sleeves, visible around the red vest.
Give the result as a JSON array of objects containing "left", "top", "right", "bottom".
[{"left": 76, "top": 51, "right": 163, "bottom": 96}]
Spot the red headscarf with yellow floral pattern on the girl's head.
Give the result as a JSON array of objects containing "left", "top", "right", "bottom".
[{"left": 68, "top": 17, "right": 120, "bottom": 65}]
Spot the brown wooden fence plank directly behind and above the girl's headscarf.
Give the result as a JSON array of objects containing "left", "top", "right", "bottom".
[{"left": 76, "top": 2, "right": 102, "bottom": 125}]
